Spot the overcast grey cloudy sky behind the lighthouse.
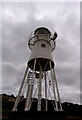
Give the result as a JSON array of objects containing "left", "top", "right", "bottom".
[{"left": 2, "top": 2, "right": 80, "bottom": 103}]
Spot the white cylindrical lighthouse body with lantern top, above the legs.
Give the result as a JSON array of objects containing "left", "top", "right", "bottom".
[{"left": 28, "top": 27, "right": 55, "bottom": 71}]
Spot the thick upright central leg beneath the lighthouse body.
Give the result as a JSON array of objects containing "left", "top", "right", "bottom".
[{"left": 37, "top": 66, "right": 42, "bottom": 111}]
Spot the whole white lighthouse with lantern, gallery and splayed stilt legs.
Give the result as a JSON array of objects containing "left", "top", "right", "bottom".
[{"left": 12, "top": 27, "right": 62, "bottom": 111}]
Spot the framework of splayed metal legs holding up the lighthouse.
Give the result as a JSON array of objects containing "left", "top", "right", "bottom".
[{"left": 12, "top": 59, "right": 62, "bottom": 111}]
